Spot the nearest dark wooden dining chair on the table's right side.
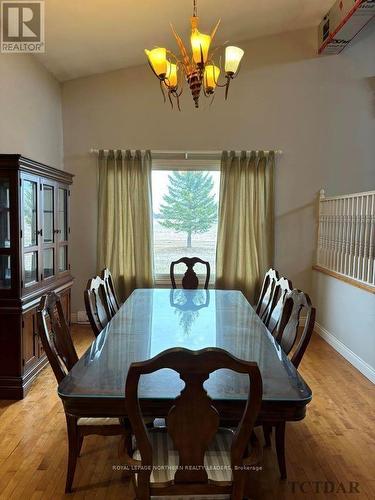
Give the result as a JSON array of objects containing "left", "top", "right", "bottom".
[{"left": 263, "top": 289, "right": 316, "bottom": 479}]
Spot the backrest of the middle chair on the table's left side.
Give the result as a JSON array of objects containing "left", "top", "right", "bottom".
[{"left": 84, "top": 276, "right": 112, "bottom": 337}]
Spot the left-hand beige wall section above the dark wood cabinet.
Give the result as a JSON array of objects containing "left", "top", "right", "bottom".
[{"left": 0, "top": 54, "right": 63, "bottom": 168}]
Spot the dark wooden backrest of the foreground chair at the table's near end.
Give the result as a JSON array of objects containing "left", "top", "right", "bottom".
[{"left": 125, "top": 347, "right": 262, "bottom": 498}]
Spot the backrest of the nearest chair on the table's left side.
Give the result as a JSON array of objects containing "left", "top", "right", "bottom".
[{"left": 37, "top": 292, "right": 78, "bottom": 383}]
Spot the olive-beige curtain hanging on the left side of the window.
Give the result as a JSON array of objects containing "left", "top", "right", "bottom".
[{"left": 97, "top": 150, "right": 153, "bottom": 300}]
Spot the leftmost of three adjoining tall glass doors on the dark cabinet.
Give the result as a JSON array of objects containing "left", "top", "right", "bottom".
[{"left": 22, "top": 178, "right": 39, "bottom": 286}]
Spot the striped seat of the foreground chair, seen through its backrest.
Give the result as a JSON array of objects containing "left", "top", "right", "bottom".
[{"left": 133, "top": 428, "right": 233, "bottom": 482}]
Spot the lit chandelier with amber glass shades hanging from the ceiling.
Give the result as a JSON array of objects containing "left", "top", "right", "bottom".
[{"left": 145, "top": 0, "right": 244, "bottom": 109}]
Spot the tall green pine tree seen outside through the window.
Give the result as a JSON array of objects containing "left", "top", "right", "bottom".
[{"left": 159, "top": 171, "right": 217, "bottom": 248}]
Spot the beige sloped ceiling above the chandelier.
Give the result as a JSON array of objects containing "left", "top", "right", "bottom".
[{"left": 38, "top": 0, "right": 333, "bottom": 81}]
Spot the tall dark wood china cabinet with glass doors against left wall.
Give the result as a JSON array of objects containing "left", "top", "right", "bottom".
[{"left": 0, "top": 155, "right": 73, "bottom": 399}]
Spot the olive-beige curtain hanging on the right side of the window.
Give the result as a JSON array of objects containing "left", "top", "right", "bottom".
[{"left": 216, "top": 151, "right": 275, "bottom": 303}]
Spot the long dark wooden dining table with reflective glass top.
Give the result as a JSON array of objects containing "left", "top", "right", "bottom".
[{"left": 58, "top": 288, "right": 312, "bottom": 436}]
